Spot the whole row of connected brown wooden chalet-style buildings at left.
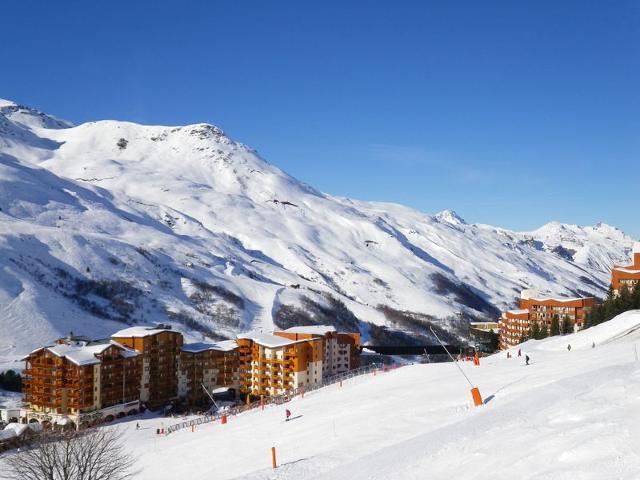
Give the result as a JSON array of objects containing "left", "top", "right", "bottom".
[{"left": 20, "top": 325, "right": 360, "bottom": 427}]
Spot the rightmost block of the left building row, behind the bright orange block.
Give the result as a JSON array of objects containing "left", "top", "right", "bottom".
[{"left": 273, "top": 325, "right": 360, "bottom": 378}]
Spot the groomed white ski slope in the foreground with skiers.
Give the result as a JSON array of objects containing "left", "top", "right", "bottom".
[{"left": 114, "top": 311, "right": 640, "bottom": 480}]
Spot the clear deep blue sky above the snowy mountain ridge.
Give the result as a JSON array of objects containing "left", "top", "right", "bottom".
[{"left": 0, "top": 0, "right": 640, "bottom": 238}]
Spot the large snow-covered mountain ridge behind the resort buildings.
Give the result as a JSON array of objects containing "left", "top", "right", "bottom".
[{"left": 0, "top": 100, "right": 633, "bottom": 360}]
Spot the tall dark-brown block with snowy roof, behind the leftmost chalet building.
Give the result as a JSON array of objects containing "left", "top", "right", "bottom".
[{"left": 111, "top": 324, "right": 184, "bottom": 409}]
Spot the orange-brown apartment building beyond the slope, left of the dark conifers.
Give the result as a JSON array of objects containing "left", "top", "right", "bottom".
[{"left": 499, "top": 290, "right": 596, "bottom": 349}]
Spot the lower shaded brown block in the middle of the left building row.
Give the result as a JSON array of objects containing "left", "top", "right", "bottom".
[{"left": 178, "top": 340, "right": 240, "bottom": 405}]
